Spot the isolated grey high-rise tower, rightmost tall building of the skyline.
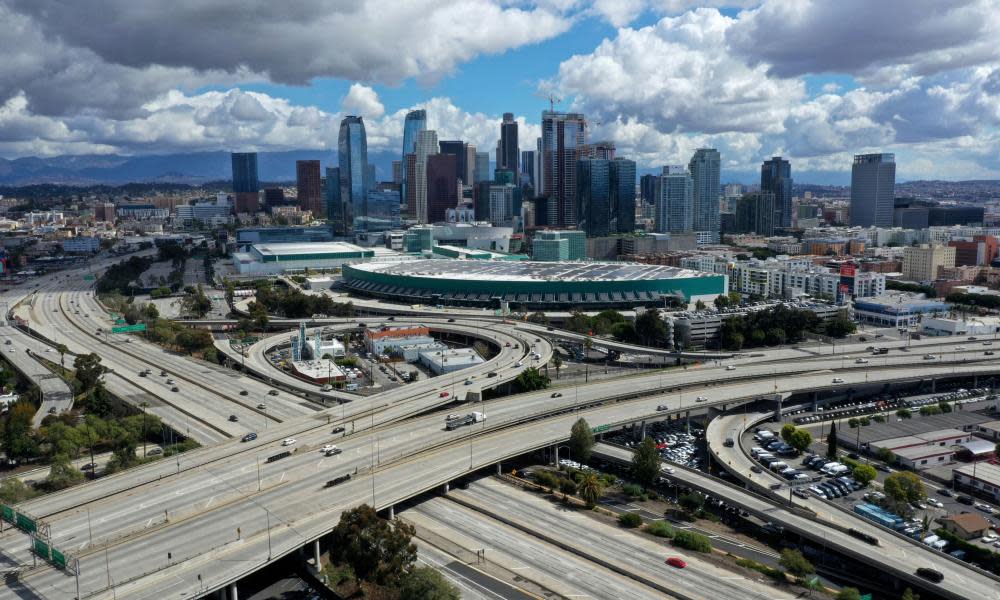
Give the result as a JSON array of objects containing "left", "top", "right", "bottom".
[{"left": 851, "top": 154, "right": 896, "bottom": 227}]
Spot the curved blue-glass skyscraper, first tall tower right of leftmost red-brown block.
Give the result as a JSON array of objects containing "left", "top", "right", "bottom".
[{"left": 337, "top": 115, "right": 374, "bottom": 233}]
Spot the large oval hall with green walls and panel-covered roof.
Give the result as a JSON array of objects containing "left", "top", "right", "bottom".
[{"left": 343, "top": 260, "right": 726, "bottom": 310}]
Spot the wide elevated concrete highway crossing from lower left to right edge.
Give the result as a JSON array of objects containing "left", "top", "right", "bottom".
[{"left": 0, "top": 365, "right": 998, "bottom": 598}]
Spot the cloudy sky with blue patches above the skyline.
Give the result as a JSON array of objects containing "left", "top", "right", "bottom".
[{"left": 0, "top": 0, "right": 1000, "bottom": 184}]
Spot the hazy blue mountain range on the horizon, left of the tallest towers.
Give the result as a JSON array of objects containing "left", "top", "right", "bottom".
[{"left": 0, "top": 150, "right": 399, "bottom": 186}]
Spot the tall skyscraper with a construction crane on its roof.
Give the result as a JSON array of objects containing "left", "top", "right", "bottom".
[{"left": 535, "top": 110, "right": 587, "bottom": 227}]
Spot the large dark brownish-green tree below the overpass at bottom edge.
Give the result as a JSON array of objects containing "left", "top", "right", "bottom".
[{"left": 331, "top": 504, "right": 417, "bottom": 586}]
